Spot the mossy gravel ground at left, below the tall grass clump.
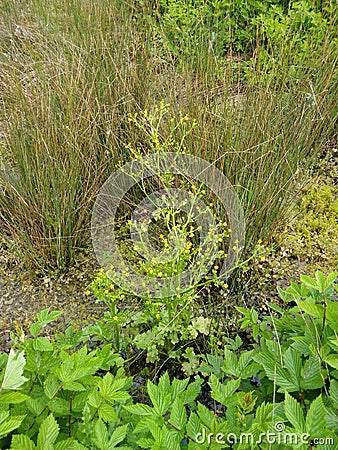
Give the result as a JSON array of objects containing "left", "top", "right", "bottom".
[{"left": 0, "top": 247, "right": 104, "bottom": 330}]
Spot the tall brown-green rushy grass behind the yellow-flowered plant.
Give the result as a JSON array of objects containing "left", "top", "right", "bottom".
[{"left": 0, "top": 0, "right": 337, "bottom": 276}]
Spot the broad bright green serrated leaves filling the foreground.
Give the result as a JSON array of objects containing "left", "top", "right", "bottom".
[{"left": 0, "top": 272, "right": 338, "bottom": 450}]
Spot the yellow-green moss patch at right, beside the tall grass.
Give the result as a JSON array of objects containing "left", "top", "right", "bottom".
[{"left": 241, "top": 177, "right": 338, "bottom": 307}]
